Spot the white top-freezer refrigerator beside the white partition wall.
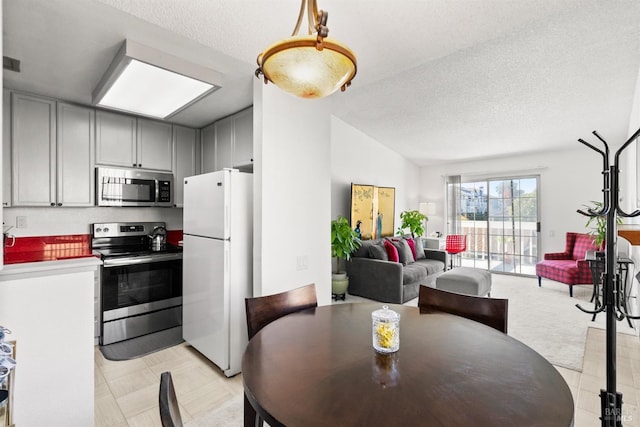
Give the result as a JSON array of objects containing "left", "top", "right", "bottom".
[{"left": 182, "top": 169, "right": 253, "bottom": 377}]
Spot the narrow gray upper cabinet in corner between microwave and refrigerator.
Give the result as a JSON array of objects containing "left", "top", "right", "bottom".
[{"left": 173, "top": 125, "right": 200, "bottom": 207}]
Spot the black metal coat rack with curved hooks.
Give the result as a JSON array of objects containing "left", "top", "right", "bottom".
[{"left": 576, "top": 129, "right": 640, "bottom": 427}]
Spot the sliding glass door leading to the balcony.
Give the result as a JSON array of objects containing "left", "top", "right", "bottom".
[{"left": 460, "top": 177, "right": 538, "bottom": 275}]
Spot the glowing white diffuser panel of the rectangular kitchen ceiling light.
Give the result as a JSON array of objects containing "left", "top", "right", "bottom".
[{"left": 97, "top": 59, "right": 214, "bottom": 118}]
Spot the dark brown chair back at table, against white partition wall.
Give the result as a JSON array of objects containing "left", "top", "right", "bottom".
[{"left": 245, "top": 283, "right": 318, "bottom": 339}]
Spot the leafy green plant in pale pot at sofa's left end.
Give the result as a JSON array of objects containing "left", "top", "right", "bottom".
[{"left": 331, "top": 216, "right": 362, "bottom": 299}]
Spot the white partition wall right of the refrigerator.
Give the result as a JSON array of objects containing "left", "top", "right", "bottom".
[{"left": 254, "top": 79, "right": 331, "bottom": 305}]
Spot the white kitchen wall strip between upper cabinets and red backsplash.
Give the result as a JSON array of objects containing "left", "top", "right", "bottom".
[{"left": 2, "top": 207, "right": 182, "bottom": 237}]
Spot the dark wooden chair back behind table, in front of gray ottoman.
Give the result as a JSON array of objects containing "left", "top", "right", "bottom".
[{"left": 418, "top": 285, "right": 509, "bottom": 334}]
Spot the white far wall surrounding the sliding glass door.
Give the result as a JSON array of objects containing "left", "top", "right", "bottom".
[{"left": 420, "top": 148, "right": 602, "bottom": 253}]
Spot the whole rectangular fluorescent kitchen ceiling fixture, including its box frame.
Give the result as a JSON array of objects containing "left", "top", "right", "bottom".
[{"left": 93, "top": 40, "right": 221, "bottom": 119}]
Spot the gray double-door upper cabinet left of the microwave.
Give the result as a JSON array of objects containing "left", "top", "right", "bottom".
[{"left": 11, "top": 93, "right": 95, "bottom": 207}]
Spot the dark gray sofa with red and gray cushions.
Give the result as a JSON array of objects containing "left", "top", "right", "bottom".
[{"left": 346, "top": 236, "right": 447, "bottom": 304}]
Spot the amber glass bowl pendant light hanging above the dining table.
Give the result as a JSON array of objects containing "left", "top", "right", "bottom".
[{"left": 256, "top": 0, "right": 357, "bottom": 98}]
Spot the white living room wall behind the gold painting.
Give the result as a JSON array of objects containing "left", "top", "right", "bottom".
[{"left": 331, "top": 116, "right": 423, "bottom": 227}]
